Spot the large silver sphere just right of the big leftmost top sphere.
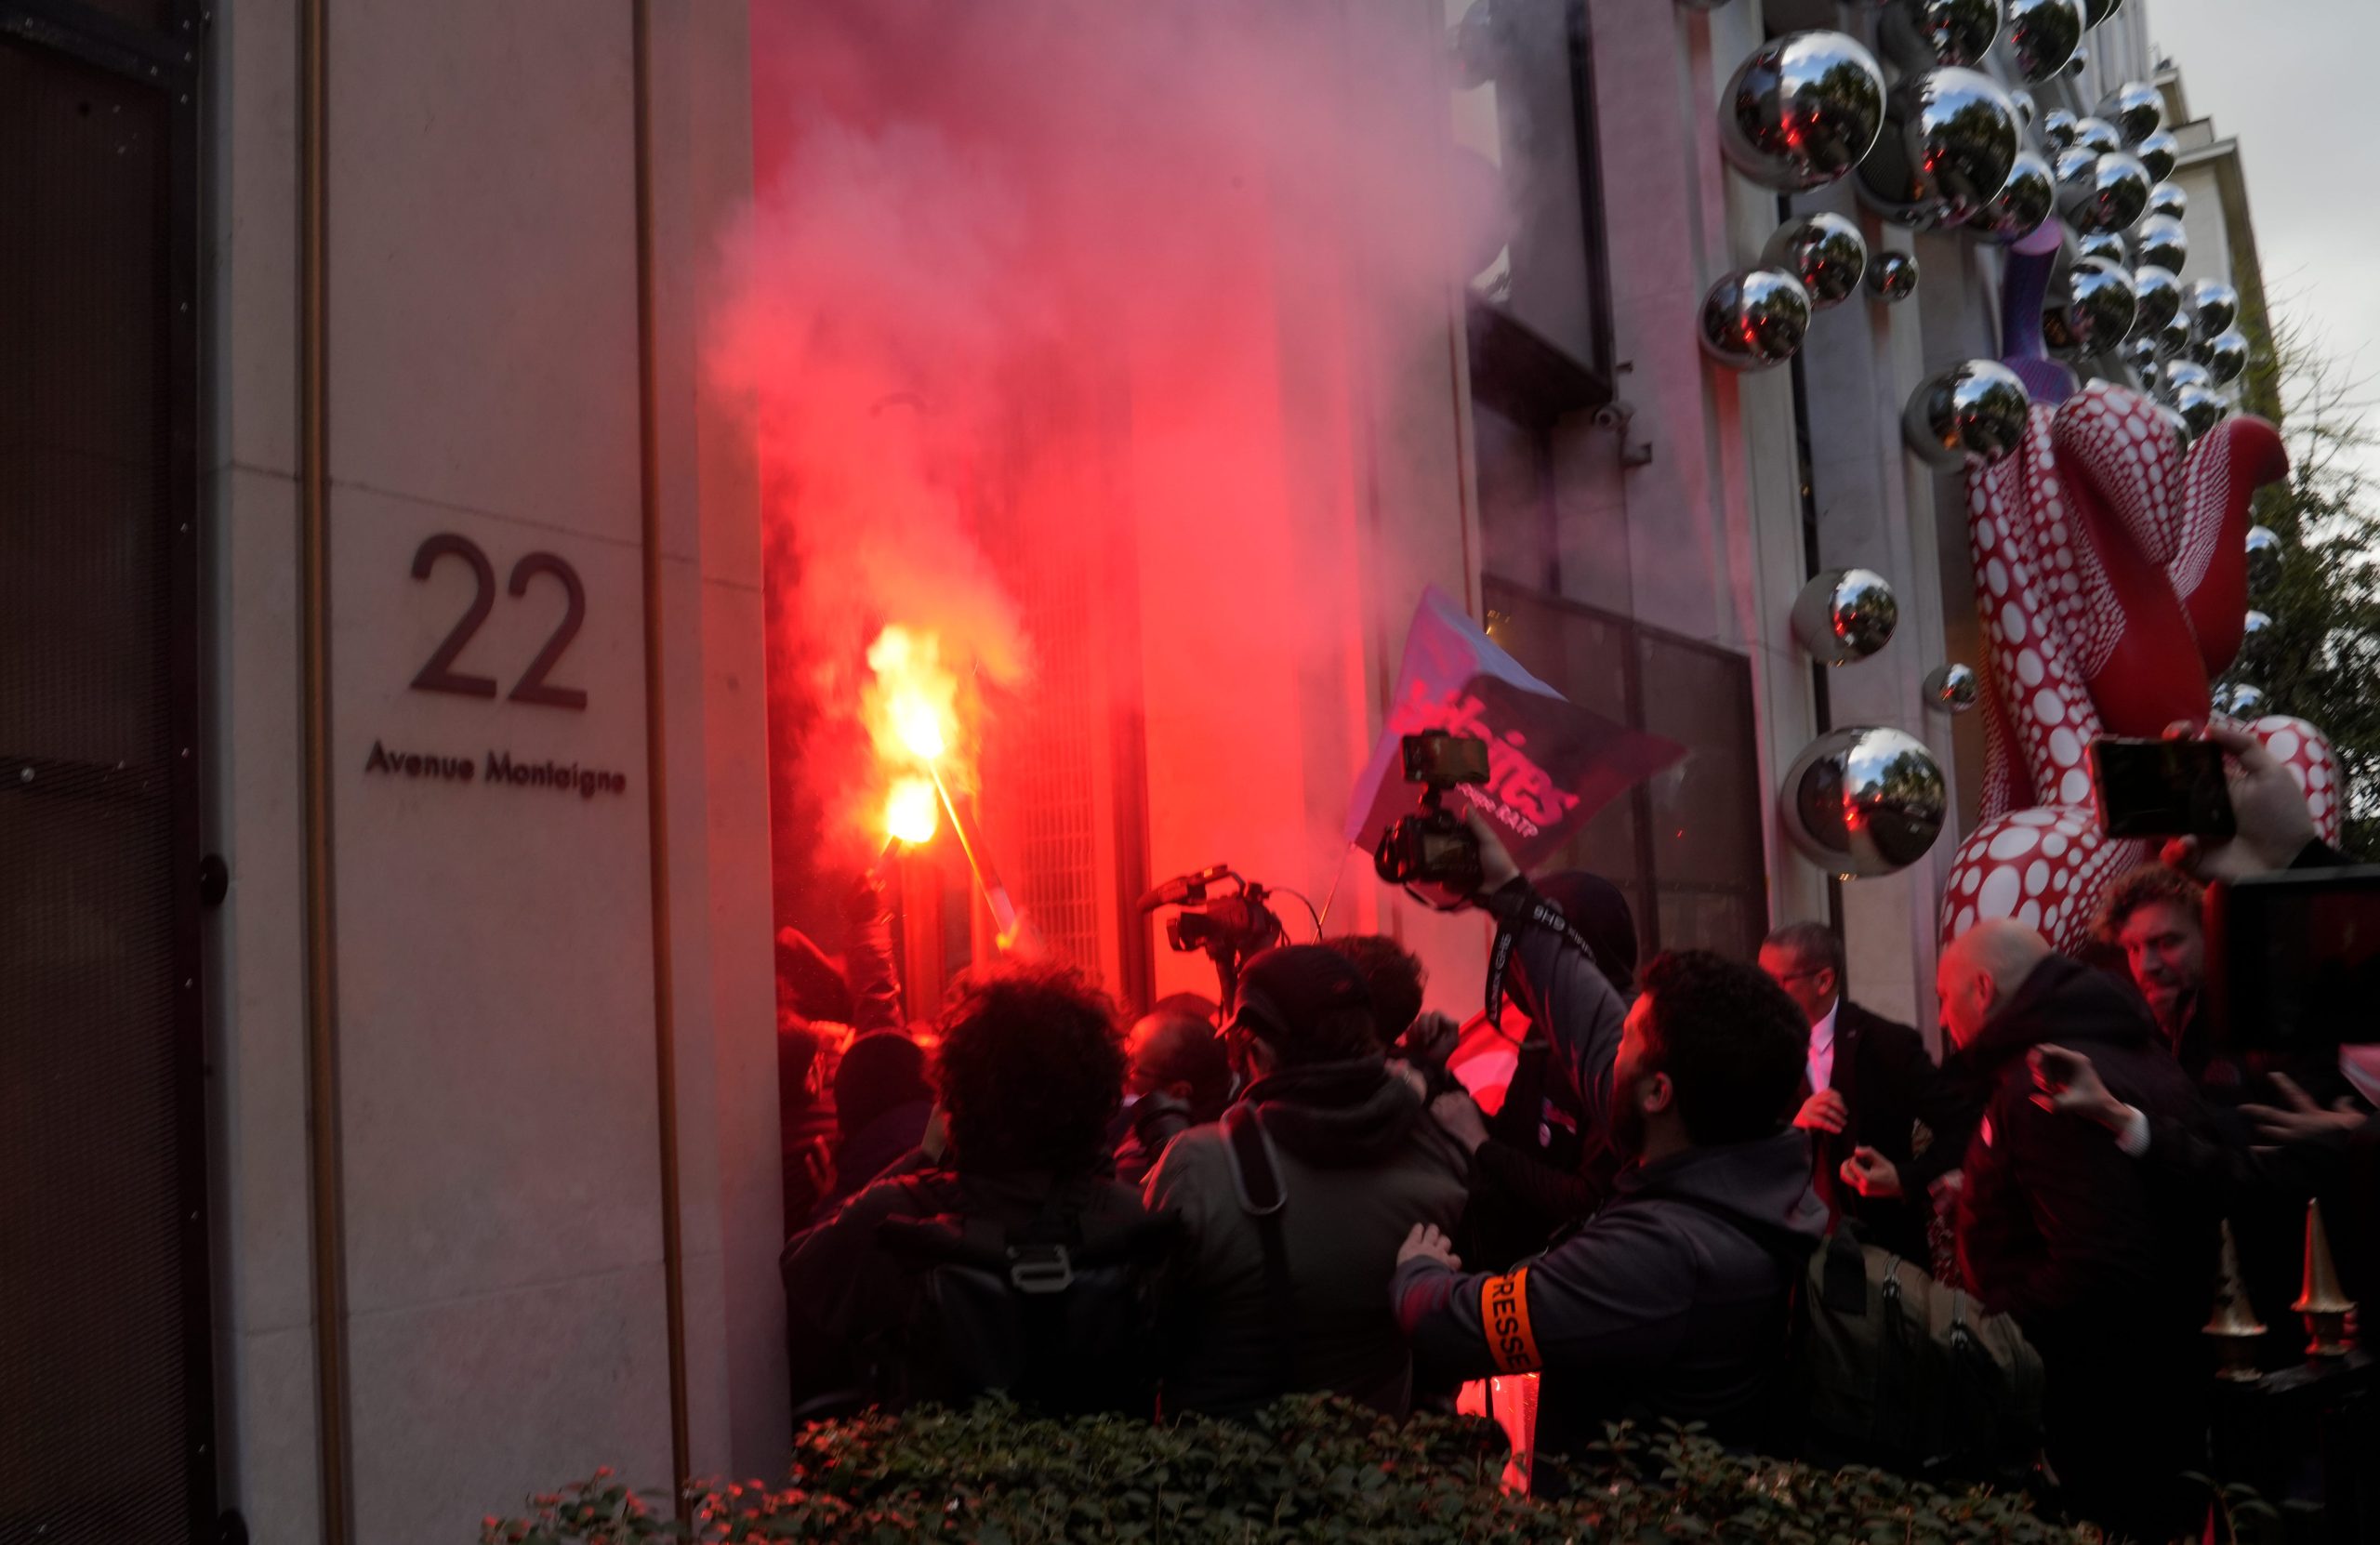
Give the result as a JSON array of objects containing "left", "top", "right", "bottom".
[{"left": 1858, "top": 64, "right": 2023, "bottom": 226}]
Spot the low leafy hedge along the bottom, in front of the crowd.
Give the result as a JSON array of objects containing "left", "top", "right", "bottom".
[{"left": 481, "top": 1397, "right": 2092, "bottom": 1545}]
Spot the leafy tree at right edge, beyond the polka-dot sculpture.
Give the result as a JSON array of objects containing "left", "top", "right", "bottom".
[{"left": 2232, "top": 321, "right": 2380, "bottom": 859}]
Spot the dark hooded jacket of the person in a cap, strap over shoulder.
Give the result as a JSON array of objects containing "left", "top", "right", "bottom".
[{"left": 1147, "top": 1057, "right": 1469, "bottom": 1417}]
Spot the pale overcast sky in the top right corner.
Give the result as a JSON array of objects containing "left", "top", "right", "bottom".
[{"left": 2147, "top": 0, "right": 2380, "bottom": 476}]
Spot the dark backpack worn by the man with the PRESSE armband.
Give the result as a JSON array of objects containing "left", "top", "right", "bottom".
[{"left": 1792, "top": 1228, "right": 2044, "bottom": 1481}]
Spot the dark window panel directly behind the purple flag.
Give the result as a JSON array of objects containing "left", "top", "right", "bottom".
[{"left": 1483, "top": 578, "right": 1768, "bottom": 959}]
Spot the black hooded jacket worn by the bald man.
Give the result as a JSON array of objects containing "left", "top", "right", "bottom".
[{"left": 1959, "top": 955, "right": 2218, "bottom": 1352}]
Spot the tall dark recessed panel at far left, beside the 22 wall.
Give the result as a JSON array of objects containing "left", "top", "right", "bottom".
[{"left": 0, "top": 0, "right": 214, "bottom": 1545}]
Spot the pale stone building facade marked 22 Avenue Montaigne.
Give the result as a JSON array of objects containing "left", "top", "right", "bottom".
[{"left": 0, "top": 0, "right": 2254, "bottom": 1545}]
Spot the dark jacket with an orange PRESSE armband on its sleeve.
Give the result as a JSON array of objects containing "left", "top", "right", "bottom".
[{"left": 1393, "top": 1130, "right": 1826, "bottom": 1455}]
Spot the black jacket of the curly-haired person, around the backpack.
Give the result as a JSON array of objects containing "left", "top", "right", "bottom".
[{"left": 778, "top": 1155, "right": 1147, "bottom": 1423}]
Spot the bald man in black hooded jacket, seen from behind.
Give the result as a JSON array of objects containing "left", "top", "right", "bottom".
[{"left": 1935, "top": 918, "right": 2218, "bottom": 1540}]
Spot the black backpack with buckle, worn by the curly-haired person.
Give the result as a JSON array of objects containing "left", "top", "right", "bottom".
[{"left": 876, "top": 1179, "right": 1181, "bottom": 1417}]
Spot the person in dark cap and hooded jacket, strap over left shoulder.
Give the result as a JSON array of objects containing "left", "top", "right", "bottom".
[{"left": 1147, "top": 945, "right": 1469, "bottom": 1417}]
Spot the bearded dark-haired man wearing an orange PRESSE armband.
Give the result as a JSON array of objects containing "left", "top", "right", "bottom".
[{"left": 1390, "top": 950, "right": 1826, "bottom": 1455}]
